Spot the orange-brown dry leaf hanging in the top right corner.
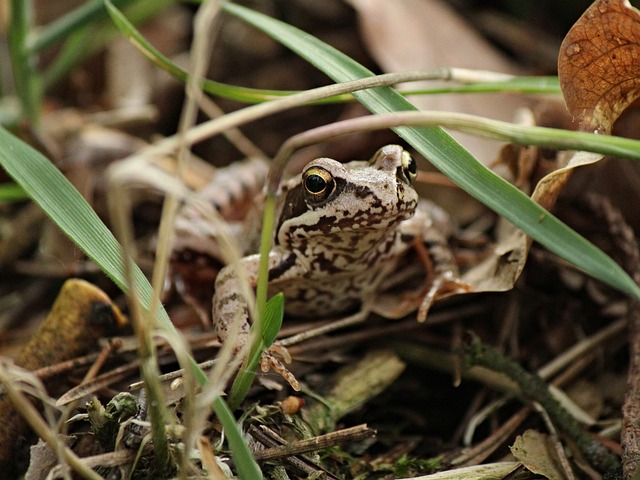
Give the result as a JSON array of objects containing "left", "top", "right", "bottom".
[{"left": 558, "top": 0, "right": 640, "bottom": 133}]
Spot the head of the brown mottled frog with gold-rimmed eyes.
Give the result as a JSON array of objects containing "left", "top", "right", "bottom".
[{"left": 277, "top": 145, "right": 418, "bottom": 243}]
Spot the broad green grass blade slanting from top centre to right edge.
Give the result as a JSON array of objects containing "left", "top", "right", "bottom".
[{"left": 223, "top": 3, "right": 640, "bottom": 298}]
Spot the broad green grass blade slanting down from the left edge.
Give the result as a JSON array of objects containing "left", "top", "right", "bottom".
[{"left": 0, "top": 127, "right": 262, "bottom": 480}]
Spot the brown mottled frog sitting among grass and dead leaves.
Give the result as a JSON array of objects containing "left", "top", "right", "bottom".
[{"left": 212, "top": 145, "right": 468, "bottom": 370}]
